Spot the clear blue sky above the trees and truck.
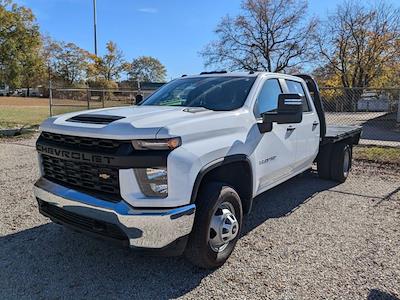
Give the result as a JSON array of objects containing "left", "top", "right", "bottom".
[{"left": 14, "top": 0, "right": 398, "bottom": 80}]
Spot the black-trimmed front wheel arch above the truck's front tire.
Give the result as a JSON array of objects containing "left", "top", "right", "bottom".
[{"left": 190, "top": 154, "right": 253, "bottom": 213}]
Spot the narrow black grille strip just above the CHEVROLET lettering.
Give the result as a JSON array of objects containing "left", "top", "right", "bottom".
[{"left": 40, "top": 131, "right": 130, "bottom": 152}]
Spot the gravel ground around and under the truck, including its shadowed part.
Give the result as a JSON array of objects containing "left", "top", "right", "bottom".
[{"left": 0, "top": 140, "right": 400, "bottom": 299}]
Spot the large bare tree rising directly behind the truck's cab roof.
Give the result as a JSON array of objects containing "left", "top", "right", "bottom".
[{"left": 200, "top": 0, "right": 316, "bottom": 72}]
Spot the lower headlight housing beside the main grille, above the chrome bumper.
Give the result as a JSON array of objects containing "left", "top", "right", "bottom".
[{"left": 135, "top": 167, "right": 168, "bottom": 198}]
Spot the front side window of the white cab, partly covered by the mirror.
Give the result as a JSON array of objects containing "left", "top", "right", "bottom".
[{"left": 254, "top": 79, "right": 282, "bottom": 118}]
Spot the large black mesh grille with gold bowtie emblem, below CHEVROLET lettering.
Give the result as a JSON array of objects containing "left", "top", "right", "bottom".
[{"left": 41, "top": 154, "right": 121, "bottom": 202}]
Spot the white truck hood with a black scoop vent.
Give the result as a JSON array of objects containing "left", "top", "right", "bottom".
[{"left": 40, "top": 106, "right": 224, "bottom": 139}]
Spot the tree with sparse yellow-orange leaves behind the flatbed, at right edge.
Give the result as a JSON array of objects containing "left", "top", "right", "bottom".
[{"left": 316, "top": 1, "right": 400, "bottom": 87}]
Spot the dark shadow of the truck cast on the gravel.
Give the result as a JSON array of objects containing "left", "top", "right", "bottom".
[{"left": 0, "top": 170, "right": 335, "bottom": 299}]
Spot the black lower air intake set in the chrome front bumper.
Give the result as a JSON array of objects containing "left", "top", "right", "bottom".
[{"left": 37, "top": 199, "right": 128, "bottom": 241}]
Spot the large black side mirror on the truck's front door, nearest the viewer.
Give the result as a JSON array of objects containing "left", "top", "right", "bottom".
[{"left": 260, "top": 94, "right": 303, "bottom": 132}]
